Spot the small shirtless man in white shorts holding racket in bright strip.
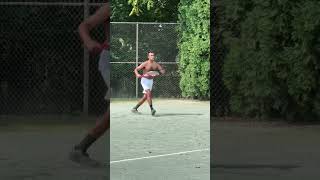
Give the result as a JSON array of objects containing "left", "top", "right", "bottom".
[{"left": 131, "top": 51, "right": 165, "bottom": 116}]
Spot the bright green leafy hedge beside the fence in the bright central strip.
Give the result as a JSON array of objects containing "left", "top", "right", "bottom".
[{"left": 179, "top": 0, "right": 210, "bottom": 99}]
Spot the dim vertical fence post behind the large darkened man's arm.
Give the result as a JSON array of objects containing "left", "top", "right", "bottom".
[{"left": 83, "top": 0, "right": 90, "bottom": 116}]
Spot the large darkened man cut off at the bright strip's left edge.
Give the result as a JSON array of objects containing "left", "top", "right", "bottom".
[{"left": 70, "top": 2, "right": 110, "bottom": 166}]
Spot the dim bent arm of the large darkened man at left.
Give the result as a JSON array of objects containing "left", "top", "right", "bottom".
[{"left": 79, "top": 3, "right": 110, "bottom": 51}]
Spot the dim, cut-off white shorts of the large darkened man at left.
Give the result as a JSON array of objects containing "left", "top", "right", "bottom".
[{"left": 99, "top": 50, "right": 110, "bottom": 100}]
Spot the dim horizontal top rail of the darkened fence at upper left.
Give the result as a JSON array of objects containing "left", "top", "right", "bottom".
[{"left": 0, "top": 1, "right": 105, "bottom": 6}]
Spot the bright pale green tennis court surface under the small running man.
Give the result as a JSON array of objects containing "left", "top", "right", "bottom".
[{"left": 110, "top": 99, "right": 210, "bottom": 180}]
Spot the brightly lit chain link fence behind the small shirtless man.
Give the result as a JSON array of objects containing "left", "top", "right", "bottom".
[{"left": 111, "top": 22, "right": 181, "bottom": 98}]
